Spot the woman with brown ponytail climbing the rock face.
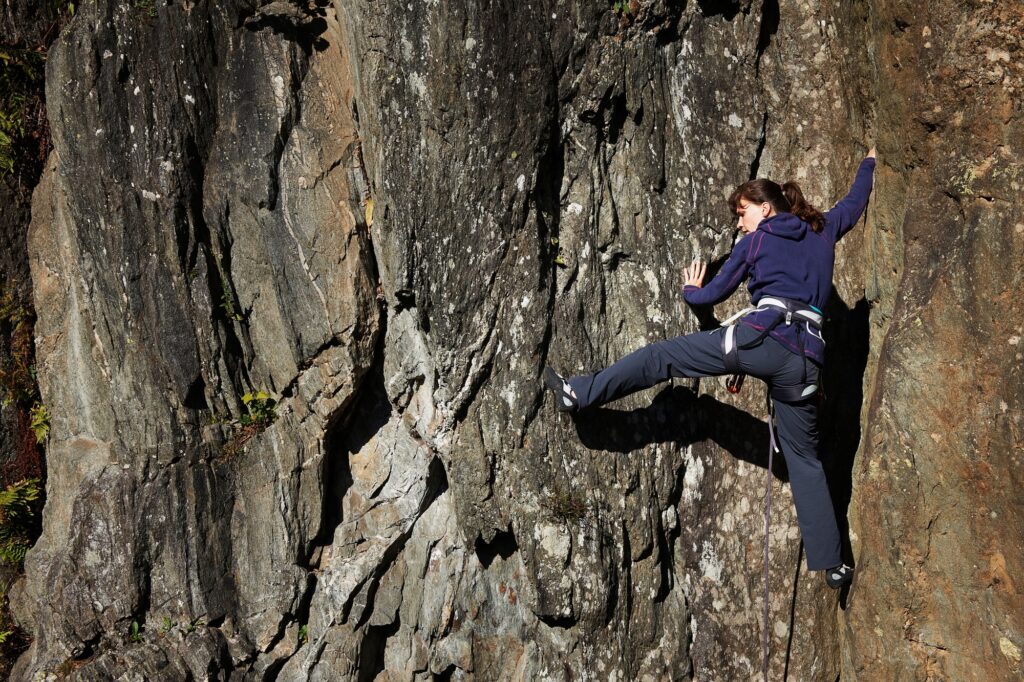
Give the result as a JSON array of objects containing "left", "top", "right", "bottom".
[{"left": 544, "top": 147, "right": 874, "bottom": 588}]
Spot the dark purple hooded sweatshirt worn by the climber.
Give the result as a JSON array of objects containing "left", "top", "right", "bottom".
[{"left": 683, "top": 159, "right": 874, "bottom": 365}]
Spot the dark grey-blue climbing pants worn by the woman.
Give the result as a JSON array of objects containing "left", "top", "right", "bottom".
[{"left": 568, "top": 324, "right": 843, "bottom": 570}]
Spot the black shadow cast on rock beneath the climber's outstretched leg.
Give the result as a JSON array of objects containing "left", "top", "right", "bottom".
[{"left": 574, "top": 379, "right": 788, "bottom": 480}]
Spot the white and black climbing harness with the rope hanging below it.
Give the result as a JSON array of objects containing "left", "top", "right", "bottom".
[{"left": 722, "top": 296, "right": 823, "bottom": 682}]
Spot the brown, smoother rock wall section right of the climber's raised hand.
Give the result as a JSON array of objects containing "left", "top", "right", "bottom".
[{"left": 843, "top": 2, "right": 1024, "bottom": 680}]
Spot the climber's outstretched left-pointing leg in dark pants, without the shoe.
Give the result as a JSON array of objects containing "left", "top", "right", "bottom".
[{"left": 568, "top": 329, "right": 726, "bottom": 409}]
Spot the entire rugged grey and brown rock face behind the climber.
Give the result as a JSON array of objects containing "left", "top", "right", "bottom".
[{"left": 13, "top": 0, "right": 1024, "bottom": 680}]
